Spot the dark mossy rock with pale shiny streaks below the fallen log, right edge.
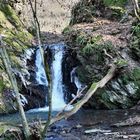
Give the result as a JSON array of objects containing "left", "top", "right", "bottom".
[{"left": 89, "top": 67, "right": 140, "bottom": 109}]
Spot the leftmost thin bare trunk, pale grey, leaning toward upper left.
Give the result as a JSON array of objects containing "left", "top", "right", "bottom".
[{"left": 0, "top": 43, "right": 30, "bottom": 140}]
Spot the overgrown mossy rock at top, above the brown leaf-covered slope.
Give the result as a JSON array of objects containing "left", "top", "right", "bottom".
[{"left": 70, "top": 0, "right": 128, "bottom": 25}]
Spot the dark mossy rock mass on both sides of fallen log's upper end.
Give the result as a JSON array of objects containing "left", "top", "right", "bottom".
[{"left": 65, "top": 25, "right": 140, "bottom": 109}]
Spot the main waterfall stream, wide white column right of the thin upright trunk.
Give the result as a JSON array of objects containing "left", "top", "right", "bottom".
[{"left": 51, "top": 44, "right": 66, "bottom": 110}]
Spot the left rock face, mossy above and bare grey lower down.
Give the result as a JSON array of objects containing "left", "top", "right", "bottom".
[{"left": 0, "top": 0, "right": 33, "bottom": 113}]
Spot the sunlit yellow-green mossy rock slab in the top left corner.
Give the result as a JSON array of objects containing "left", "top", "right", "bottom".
[{"left": 0, "top": 0, "right": 33, "bottom": 52}]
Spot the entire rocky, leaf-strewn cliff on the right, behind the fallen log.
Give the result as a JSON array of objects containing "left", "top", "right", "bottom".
[{"left": 63, "top": 0, "right": 140, "bottom": 109}]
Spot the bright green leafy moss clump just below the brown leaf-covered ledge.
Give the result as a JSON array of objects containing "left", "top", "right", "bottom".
[{"left": 75, "top": 32, "right": 114, "bottom": 58}]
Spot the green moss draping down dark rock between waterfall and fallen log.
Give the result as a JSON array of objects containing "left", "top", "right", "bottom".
[{"left": 73, "top": 32, "right": 116, "bottom": 84}]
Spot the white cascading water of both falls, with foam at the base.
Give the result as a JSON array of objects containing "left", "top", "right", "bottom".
[{"left": 29, "top": 43, "right": 72, "bottom": 112}]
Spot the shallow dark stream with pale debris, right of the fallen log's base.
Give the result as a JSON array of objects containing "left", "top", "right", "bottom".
[{"left": 47, "top": 110, "right": 140, "bottom": 140}]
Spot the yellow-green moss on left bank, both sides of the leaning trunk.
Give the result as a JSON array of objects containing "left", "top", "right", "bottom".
[{"left": 0, "top": 0, "right": 33, "bottom": 98}]
